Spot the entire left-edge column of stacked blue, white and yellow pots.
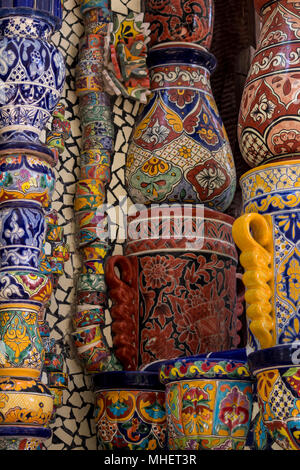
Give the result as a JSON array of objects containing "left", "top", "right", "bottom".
[{"left": 0, "top": 0, "right": 65, "bottom": 449}]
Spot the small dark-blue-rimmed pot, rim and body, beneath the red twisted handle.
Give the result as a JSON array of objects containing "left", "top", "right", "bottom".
[{"left": 93, "top": 371, "right": 166, "bottom": 451}]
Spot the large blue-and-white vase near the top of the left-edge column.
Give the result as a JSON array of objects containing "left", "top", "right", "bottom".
[{"left": 0, "top": 21, "right": 65, "bottom": 141}]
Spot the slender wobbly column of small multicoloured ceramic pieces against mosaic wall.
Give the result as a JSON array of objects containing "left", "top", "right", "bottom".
[{"left": 72, "top": 0, "right": 120, "bottom": 373}]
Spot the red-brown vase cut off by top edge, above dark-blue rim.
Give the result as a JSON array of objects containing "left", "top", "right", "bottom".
[{"left": 144, "top": 0, "right": 214, "bottom": 49}]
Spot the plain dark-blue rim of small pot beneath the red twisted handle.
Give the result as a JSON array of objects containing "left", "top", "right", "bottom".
[{"left": 92, "top": 371, "right": 165, "bottom": 391}]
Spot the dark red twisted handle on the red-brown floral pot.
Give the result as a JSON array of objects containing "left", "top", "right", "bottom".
[{"left": 105, "top": 255, "right": 139, "bottom": 370}]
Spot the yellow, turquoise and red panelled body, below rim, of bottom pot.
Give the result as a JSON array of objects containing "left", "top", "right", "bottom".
[{"left": 166, "top": 378, "right": 252, "bottom": 450}]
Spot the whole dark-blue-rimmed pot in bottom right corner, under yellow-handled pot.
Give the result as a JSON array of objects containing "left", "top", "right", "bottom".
[{"left": 248, "top": 342, "right": 300, "bottom": 450}]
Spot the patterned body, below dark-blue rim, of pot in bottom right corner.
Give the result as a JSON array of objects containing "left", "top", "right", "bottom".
[{"left": 257, "top": 366, "right": 300, "bottom": 450}]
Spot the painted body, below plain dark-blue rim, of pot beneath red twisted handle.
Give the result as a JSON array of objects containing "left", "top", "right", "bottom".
[{"left": 95, "top": 390, "right": 166, "bottom": 450}]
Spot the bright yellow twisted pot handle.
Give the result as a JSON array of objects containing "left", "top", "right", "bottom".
[{"left": 232, "top": 213, "right": 275, "bottom": 348}]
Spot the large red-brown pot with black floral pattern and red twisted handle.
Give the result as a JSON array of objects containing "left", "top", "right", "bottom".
[{"left": 105, "top": 205, "right": 239, "bottom": 370}]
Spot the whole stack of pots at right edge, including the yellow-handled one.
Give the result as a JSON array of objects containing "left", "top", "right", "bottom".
[{"left": 233, "top": 0, "right": 300, "bottom": 450}]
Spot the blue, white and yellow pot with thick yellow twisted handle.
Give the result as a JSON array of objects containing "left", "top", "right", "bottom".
[{"left": 233, "top": 160, "right": 300, "bottom": 350}]
